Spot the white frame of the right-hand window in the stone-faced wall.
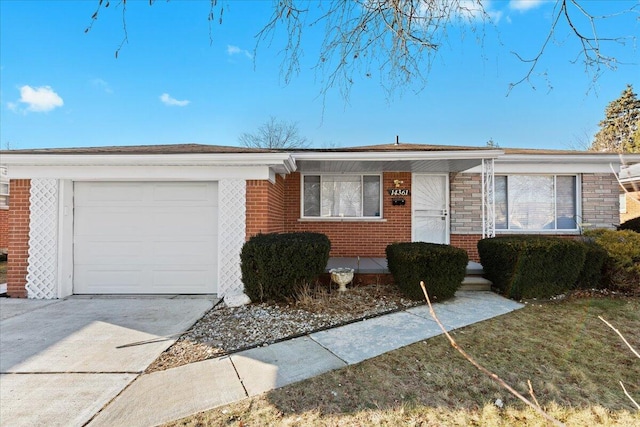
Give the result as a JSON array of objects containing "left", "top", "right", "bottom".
[{"left": 495, "top": 173, "right": 584, "bottom": 234}]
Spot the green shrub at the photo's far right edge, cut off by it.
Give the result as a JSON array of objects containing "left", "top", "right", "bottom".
[{"left": 584, "top": 229, "right": 640, "bottom": 293}]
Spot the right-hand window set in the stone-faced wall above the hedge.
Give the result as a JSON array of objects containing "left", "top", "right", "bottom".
[{"left": 495, "top": 175, "right": 580, "bottom": 231}]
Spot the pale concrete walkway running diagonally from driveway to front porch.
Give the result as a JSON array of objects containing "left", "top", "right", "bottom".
[{"left": 89, "top": 291, "right": 523, "bottom": 427}]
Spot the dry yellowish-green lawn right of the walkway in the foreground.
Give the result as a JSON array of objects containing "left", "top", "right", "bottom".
[{"left": 168, "top": 298, "right": 640, "bottom": 426}]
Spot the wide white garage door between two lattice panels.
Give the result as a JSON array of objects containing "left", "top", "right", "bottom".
[{"left": 73, "top": 182, "right": 218, "bottom": 294}]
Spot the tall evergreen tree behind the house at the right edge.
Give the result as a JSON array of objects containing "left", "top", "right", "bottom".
[{"left": 590, "top": 84, "right": 640, "bottom": 153}]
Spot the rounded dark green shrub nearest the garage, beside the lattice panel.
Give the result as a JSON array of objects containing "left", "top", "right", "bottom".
[{"left": 240, "top": 233, "right": 331, "bottom": 302}]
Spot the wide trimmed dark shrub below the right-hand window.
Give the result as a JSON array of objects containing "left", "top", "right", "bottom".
[{"left": 478, "top": 235, "right": 587, "bottom": 299}]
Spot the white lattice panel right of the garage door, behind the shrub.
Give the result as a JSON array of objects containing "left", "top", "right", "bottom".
[{"left": 218, "top": 179, "right": 249, "bottom": 306}]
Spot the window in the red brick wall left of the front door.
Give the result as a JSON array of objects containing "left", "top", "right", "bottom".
[{"left": 302, "top": 175, "right": 382, "bottom": 218}]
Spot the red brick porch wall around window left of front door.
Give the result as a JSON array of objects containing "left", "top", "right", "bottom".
[{"left": 284, "top": 172, "right": 411, "bottom": 257}]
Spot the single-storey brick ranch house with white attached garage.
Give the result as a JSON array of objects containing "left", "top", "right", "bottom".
[{"left": 2, "top": 143, "right": 640, "bottom": 305}]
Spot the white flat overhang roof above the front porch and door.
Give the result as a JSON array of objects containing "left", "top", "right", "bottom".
[{"left": 292, "top": 149, "right": 504, "bottom": 173}]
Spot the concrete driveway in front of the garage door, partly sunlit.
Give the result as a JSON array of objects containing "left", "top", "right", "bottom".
[{"left": 0, "top": 296, "right": 214, "bottom": 426}]
